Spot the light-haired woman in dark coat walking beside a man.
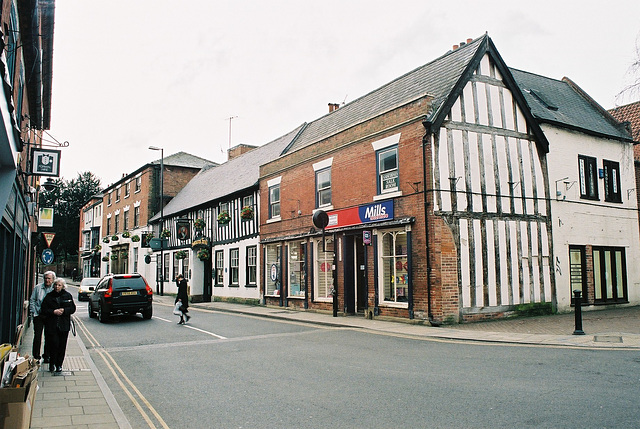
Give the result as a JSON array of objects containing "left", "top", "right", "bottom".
[{"left": 40, "top": 278, "right": 76, "bottom": 373}]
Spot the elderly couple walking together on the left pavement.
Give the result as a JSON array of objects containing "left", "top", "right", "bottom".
[{"left": 29, "top": 271, "right": 76, "bottom": 373}]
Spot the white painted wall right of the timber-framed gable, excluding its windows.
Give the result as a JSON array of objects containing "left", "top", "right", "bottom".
[{"left": 542, "top": 125, "right": 640, "bottom": 311}]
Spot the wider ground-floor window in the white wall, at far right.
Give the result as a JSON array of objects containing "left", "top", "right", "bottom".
[{"left": 593, "top": 246, "right": 628, "bottom": 304}]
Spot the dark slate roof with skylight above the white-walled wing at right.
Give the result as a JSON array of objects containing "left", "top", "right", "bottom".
[{"left": 509, "top": 68, "right": 631, "bottom": 140}]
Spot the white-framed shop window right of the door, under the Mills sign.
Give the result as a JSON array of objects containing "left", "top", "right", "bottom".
[{"left": 379, "top": 230, "right": 409, "bottom": 302}]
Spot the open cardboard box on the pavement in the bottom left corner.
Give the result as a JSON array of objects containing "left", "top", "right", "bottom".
[{"left": 0, "top": 377, "right": 38, "bottom": 429}]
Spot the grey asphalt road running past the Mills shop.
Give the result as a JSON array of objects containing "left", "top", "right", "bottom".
[{"left": 70, "top": 290, "right": 640, "bottom": 428}]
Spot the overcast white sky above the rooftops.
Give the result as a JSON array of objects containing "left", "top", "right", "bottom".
[{"left": 49, "top": 0, "right": 640, "bottom": 187}]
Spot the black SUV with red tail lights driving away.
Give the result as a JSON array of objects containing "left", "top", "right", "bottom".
[{"left": 88, "top": 274, "right": 153, "bottom": 323}]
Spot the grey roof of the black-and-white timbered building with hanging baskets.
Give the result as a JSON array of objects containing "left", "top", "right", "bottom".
[{"left": 151, "top": 125, "right": 304, "bottom": 217}]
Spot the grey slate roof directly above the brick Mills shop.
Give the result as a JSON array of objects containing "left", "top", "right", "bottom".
[{"left": 287, "top": 35, "right": 488, "bottom": 152}]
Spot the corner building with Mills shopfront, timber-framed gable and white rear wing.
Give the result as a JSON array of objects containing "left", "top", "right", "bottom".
[{"left": 260, "top": 35, "right": 639, "bottom": 324}]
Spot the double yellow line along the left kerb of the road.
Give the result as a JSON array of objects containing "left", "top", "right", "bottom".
[{"left": 74, "top": 316, "right": 170, "bottom": 429}]
